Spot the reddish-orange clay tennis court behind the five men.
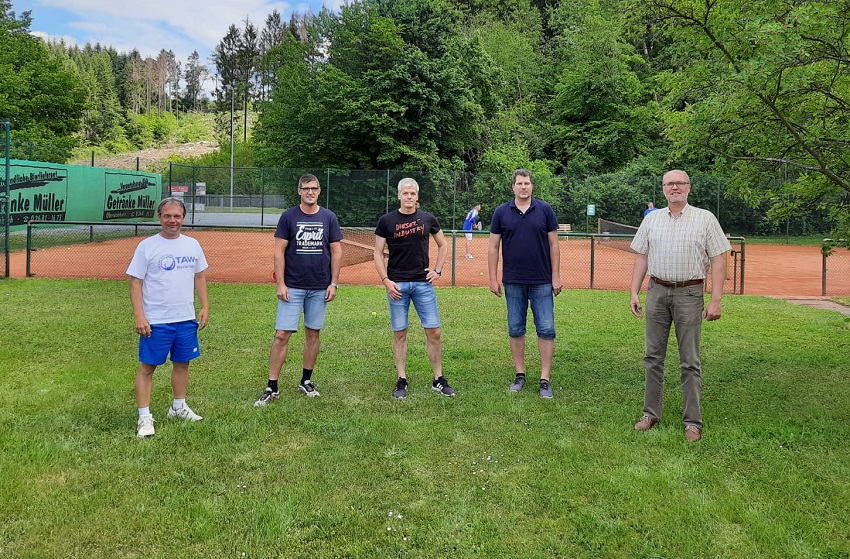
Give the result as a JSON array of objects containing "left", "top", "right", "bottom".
[{"left": 10, "top": 228, "right": 850, "bottom": 297}]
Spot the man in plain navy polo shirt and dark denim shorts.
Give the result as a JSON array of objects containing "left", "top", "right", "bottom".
[{"left": 487, "top": 169, "right": 563, "bottom": 398}]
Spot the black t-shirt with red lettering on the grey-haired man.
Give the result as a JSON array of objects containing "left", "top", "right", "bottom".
[{"left": 375, "top": 210, "right": 440, "bottom": 281}]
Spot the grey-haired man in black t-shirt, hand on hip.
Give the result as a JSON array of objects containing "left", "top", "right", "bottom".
[{"left": 374, "top": 178, "right": 455, "bottom": 399}]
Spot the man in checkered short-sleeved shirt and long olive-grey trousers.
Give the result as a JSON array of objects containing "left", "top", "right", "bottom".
[{"left": 629, "top": 170, "right": 732, "bottom": 442}]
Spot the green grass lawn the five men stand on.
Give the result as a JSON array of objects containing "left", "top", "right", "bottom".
[{"left": 0, "top": 279, "right": 850, "bottom": 559}]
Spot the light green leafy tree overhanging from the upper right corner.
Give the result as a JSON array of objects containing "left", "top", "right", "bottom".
[{"left": 639, "top": 0, "right": 850, "bottom": 238}]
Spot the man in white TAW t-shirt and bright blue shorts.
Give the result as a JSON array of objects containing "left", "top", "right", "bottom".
[{"left": 127, "top": 198, "right": 210, "bottom": 438}]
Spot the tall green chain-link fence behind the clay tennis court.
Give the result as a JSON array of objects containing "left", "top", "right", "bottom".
[{"left": 162, "top": 164, "right": 830, "bottom": 235}]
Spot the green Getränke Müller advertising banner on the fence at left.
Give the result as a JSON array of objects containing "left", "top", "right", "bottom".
[{"left": 0, "top": 159, "right": 162, "bottom": 230}]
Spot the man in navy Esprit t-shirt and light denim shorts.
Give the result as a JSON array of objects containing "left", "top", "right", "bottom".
[{"left": 254, "top": 174, "right": 342, "bottom": 407}]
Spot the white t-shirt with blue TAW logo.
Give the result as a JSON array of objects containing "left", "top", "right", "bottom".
[{"left": 127, "top": 235, "right": 208, "bottom": 324}]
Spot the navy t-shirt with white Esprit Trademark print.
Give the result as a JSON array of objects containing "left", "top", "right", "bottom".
[{"left": 274, "top": 206, "right": 342, "bottom": 289}]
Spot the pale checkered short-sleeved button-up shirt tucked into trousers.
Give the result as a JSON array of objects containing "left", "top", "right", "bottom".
[{"left": 631, "top": 205, "right": 732, "bottom": 282}]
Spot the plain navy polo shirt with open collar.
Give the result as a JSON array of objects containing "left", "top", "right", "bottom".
[{"left": 490, "top": 198, "right": 558, "bottom": 284}]
